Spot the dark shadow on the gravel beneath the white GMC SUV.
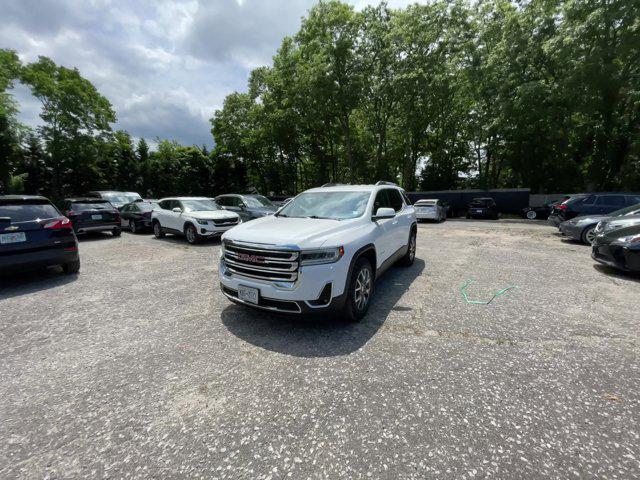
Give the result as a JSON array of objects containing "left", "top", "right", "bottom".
[{"left": 221, "top": 259, "right": 425, "bottom": 358}]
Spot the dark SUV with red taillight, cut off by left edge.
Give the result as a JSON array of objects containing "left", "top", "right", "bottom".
[{"left": 0, "top": 195, "right": 80, "bottom": 273}]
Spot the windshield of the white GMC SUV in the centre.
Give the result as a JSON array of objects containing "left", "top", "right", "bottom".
[{"left": 278, "top": 192, "right": 371, "bottom": 220}]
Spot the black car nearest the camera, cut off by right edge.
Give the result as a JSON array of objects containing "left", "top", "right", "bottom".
[{"left": 591, "top": 225, "right": 640, "bottom": 272}]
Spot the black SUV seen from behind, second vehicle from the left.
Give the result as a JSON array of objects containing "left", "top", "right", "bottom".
[{"left": 62, "top": 197, "right": 122, "bottom": 237}]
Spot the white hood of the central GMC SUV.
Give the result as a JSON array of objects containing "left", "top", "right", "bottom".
[{"left": 222, "top": 215, "right": 356, "bottom": 248}]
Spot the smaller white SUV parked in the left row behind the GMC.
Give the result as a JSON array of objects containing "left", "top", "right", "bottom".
[{"left": 151, "top": 197, "right": 242, "bottom": 244}]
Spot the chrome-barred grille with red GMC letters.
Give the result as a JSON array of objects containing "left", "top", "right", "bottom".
[{"left": 224, "top": 240, "right": 300, "bottom": 282}]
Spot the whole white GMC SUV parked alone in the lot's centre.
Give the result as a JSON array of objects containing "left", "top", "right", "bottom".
[{"left": 219, "top": 182, "right": 416, "bottom": 320}]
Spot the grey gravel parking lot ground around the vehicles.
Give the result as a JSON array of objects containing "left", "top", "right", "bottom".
[{"left": 0, "top": 220, "right": 640, "bottom": 479}]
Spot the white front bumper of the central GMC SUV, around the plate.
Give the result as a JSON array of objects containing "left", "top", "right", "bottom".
[{"left": 219, "top": 257, "right": 349, "bottom": 314}]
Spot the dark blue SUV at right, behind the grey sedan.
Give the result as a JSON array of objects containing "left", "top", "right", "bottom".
[{"left": 549, "top": 193, "right": 640, "bottom": 226}]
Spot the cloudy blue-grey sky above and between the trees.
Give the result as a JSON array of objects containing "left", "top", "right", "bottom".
[{"left": 0, "top": 0, "right": 415, "bottom": 145}]
